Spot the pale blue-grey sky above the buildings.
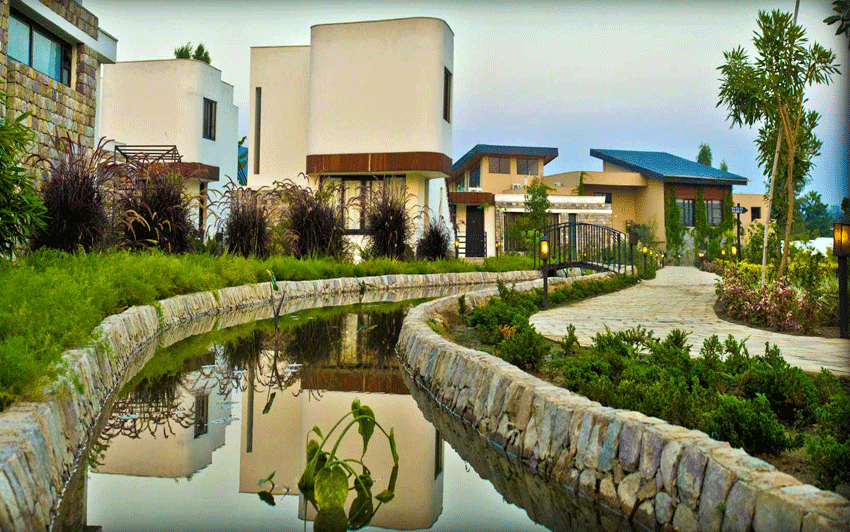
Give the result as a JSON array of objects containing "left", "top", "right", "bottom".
[{"left": 88, "top": 0, "right": 850, "bottom": 204}]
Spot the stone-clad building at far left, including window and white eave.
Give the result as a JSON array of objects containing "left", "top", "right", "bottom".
[{"left": 0, "top": 0, "right": 117, "bottom": 169}]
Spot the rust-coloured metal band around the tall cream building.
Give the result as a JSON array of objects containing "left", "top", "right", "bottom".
[{"left": 307, "top": 151, "right": 452, "bottom": 176}]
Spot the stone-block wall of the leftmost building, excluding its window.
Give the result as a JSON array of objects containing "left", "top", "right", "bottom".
[{"left": 0, "top": 0, "right": 99, "bottom": 168}]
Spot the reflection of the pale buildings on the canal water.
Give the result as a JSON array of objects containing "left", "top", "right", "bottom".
[{"left": 95, "top": 310, "right": 444, "bottom": 530}]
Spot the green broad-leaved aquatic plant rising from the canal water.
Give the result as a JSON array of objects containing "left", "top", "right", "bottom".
[{"left": 259, "top": 399, "right": 398, "bottom": 532}]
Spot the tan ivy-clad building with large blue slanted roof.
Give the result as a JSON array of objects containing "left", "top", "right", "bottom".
[{"left": 544, "top": 149, "right": 747, "bottom": 248}]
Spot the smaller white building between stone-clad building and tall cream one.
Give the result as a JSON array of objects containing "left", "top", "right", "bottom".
[{"left": 98, "top": 59, "right": 239, "bottom": 233}]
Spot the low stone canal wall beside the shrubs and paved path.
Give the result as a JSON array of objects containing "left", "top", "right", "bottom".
[{"left": 397, "top": 274, "right": 850, "bottom": 532}]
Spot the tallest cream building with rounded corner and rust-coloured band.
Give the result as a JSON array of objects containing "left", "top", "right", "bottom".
[{"left": 247, "top": 18, "right": 454, "bottom": 248}]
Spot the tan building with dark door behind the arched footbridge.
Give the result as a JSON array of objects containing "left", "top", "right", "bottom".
[{"left": 448, "top": 144, "right": 611, "bottom": 258}]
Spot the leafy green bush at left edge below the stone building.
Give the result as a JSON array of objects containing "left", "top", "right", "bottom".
[{"left": 0, "top": 92, "right": 45, "bottom": 260}]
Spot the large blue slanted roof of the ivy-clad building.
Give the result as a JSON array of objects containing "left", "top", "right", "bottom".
[{"left": 590, "top": 150, "right": 747, "bottom": 185}]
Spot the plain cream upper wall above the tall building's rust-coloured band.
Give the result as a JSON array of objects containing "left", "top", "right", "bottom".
[{"left": 307, "top": 18, "right": 454, "bottom": 160}]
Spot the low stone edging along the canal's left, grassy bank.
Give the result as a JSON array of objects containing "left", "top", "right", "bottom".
[{"left": 0, "top": 270, "right": 540, "bottom": 531}]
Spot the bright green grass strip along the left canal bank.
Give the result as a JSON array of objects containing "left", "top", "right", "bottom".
[{"left": 0, "top": 249, "right": 533, "bottom": 408}]
